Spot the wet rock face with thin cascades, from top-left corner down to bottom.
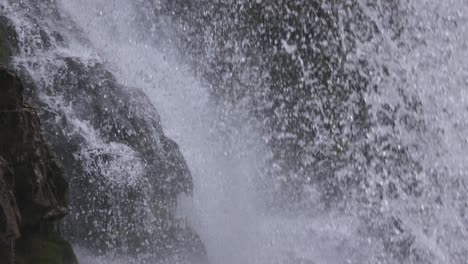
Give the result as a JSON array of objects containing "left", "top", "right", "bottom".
[{"left": 0, "top": 1, "right": 206, "bottom": 263}]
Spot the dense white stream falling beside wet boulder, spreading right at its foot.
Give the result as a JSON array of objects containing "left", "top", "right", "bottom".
[{"left": 54, "top": 0, "right": 370, "bottom": 264}]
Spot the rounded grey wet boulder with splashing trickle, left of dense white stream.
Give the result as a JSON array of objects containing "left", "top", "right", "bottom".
[{"left": 21, "top": 57, "right": 204, "bottom": 259}]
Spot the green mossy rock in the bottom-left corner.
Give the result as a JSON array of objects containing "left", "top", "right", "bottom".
[{"left": 0, "top": 234, "right": 78, "bottom": 264}]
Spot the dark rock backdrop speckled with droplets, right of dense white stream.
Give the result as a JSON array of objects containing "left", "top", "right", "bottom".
[{"left": 154, "top": 0, "right": 414, "bottom": 204}]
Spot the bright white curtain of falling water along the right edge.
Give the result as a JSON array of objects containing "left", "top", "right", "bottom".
[{"left": 356, "top": 0, "right": 468, "bottom": 263}]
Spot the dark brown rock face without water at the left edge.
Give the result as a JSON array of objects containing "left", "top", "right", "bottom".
[{"left": 0, "top": 67, "right": 74, "bottom": 263}]
